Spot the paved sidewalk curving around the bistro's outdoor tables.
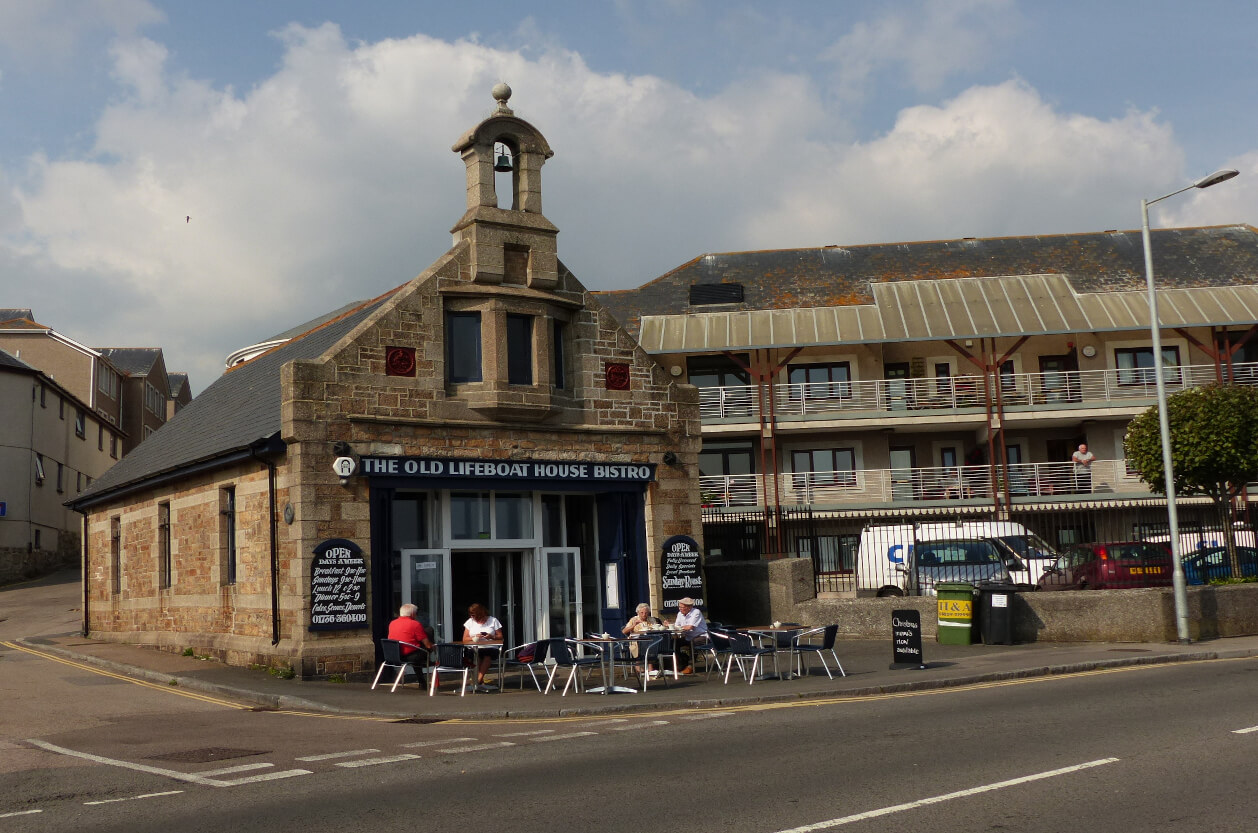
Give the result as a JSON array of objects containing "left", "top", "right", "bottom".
[{"left": 16, "top": 634, "right": 1258, "bottom": 722}]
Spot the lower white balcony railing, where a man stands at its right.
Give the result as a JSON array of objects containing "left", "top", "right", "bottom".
[{"left": 699, "top": 459, "right": 1150, "bottom": 507}]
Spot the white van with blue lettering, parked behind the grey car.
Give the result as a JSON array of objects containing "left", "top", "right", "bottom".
[{"left": 857, "top": 521, "right": 1057, "bottom": 596}]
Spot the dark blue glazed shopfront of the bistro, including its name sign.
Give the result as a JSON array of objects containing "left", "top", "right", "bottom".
[{"left": 356, "top": 456, "right": 655, "bottom": 644}]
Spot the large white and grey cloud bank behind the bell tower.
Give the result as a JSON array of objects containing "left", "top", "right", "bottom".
[{"left": 0, "top": 25, "right": 1255, "bottom": 390}]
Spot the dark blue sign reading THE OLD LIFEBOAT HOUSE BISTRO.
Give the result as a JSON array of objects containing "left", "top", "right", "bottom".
[{"left": 359, "top": 457, "right": 655, "bottom": 483}]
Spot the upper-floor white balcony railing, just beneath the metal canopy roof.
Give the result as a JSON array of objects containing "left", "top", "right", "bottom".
[{"left": 699, "top": 362, "right": 1258, "bottom": 422}]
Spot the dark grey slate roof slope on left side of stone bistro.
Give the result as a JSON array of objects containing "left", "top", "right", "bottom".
[{"left": 69, "top": 293, "right": 392, "bottom": 510}]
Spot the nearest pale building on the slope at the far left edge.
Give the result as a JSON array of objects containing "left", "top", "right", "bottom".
[{"left": 0, "top": 350, "right": 121, "bottom": 584}]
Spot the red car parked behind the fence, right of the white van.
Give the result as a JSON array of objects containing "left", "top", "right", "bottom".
[{"left": 1037, "top": 541, "right": 1171, "bottom": 590}]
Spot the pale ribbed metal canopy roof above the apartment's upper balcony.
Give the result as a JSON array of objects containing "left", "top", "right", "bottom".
[{"left": 639, "top": 274, "right": 1258, "bottom": 354}]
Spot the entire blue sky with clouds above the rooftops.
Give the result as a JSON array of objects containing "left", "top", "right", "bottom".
[{"left": 0, "top": 0, "right": 1258, "bottom": 390}]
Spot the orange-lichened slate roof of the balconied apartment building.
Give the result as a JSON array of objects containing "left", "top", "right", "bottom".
[{"left": 594, "top": 224, "right": 1258, "bottom": 337}]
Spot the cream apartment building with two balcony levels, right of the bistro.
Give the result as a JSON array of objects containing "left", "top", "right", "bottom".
[{"left": 598, "top": 225, "right": 1258, "bottom": 571}]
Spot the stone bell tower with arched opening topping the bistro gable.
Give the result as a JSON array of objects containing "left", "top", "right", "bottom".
[{"left": 450, "top": 83, "right": 559, "bottom": 289}]
